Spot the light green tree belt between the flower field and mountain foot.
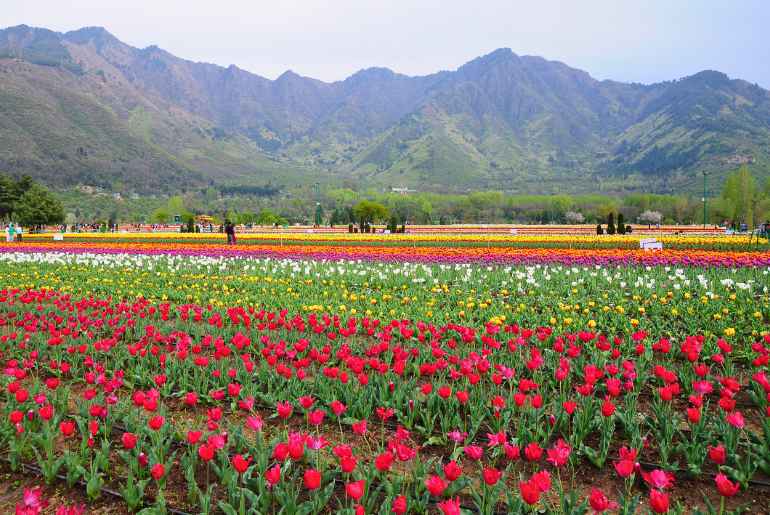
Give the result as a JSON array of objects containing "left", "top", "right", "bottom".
[{"left": 18, "top": 167, "right": 770, "bottom": 230}]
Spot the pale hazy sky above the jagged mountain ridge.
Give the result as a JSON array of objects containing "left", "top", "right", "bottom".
[{"left": 0, "top": 0, "right": 770, "bottom": 87}]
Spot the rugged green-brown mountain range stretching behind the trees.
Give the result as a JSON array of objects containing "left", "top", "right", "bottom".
[{"left": 0, "top": 25, "right": 770, "bottom": 193}]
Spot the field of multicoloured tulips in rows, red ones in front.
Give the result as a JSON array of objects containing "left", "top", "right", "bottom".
[{"left": 0, "top": 235, "right": 770, "bottom": 515}]
